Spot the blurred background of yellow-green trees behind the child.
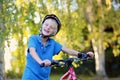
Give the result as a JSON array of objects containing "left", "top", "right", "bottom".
[{"left": 0, "top": 0, "right": 120, "bottom": 80}]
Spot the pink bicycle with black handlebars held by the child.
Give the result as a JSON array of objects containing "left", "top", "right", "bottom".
[{"left": 41, "top": 55, "right": 92, "bottom": 80}]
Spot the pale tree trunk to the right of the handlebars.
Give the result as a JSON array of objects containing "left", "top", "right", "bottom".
[{"left": 86, "top": 0, "right": 106, "bottom": 78}]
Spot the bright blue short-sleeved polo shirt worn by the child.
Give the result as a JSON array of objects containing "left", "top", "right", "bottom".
[{"left": 22, "top": 35, "right": 62, "bottom": 80}]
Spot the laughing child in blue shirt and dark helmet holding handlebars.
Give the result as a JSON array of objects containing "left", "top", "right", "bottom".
[{"left": 22, "top": 14, "right": 94, "bottom": 80}]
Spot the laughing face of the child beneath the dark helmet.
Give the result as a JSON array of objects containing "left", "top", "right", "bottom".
[{"left": 42, "top": 19, "right": 58, "bottom": 36}]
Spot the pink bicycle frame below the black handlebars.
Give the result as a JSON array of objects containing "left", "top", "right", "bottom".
[{"left": 60, "top": 67, "right": 77, "bottom": 80}]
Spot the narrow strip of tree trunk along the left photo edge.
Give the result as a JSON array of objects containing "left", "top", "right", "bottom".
[{"left": 0, "top": 1, "right": 5, "bottom": 80}]
